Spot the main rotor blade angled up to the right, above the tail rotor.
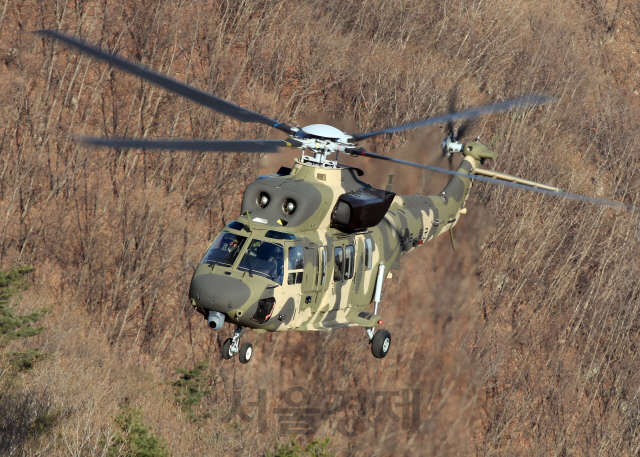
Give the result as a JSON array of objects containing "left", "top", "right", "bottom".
[{"left": 352, "top": 94, "right": 554, "bottom": 141}]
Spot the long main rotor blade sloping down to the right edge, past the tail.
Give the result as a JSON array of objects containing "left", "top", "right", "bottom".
[{"left": 346, "top": 149, "right": 640, "bottom": 211}]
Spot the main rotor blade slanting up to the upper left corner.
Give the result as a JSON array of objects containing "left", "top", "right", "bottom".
[{"left": 36, "top": 30, "right": 293, "bottom": 133}]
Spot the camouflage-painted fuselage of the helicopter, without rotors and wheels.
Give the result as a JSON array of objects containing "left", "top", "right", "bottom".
[{"left": 189, "top": 152, "right": 477, "bottom": 332}]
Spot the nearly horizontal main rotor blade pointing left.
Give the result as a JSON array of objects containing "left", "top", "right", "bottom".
[{"left": 80, "top": 137, "right": 296, "bottom": 153}]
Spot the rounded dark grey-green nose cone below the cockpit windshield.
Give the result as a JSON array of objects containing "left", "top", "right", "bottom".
[{"left": 189, "top": 271, "right": 251, "bottom": 313}]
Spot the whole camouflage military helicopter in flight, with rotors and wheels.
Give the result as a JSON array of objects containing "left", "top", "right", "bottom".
[{"left": 38, "top": 30, "right": 631, "bottom": 363}]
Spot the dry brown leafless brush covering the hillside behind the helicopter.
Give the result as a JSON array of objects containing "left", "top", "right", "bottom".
[{"left": 0, "top": 0, "right": 640, "bottom": 456}]
